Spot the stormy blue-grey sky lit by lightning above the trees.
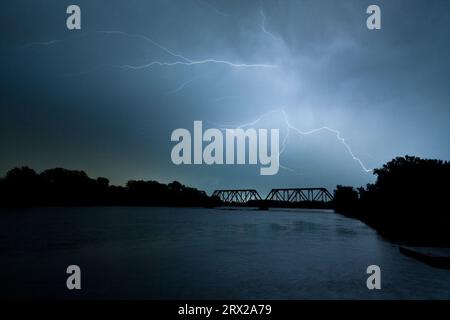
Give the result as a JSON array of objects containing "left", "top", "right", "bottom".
[{"left": 0, "top": 0, "right": 450, "bottom": 194}]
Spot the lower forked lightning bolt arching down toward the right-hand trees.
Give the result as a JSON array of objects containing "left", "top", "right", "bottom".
[{"left": 214, "top": 109, "right": 373, "bottom": 173}]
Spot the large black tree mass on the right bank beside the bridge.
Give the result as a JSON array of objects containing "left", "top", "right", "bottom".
[{"left": 334, "top": 156, "right": 450, "bottom": 246}]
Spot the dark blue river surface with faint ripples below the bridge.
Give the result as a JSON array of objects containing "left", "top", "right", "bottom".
[{"left": 0, "top": 207, "right": 450, "bottom": 299}]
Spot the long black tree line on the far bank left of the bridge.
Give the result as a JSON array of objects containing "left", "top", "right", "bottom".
[{"left": 0, "top": 167, "right": 220, "bottom": 207}]
